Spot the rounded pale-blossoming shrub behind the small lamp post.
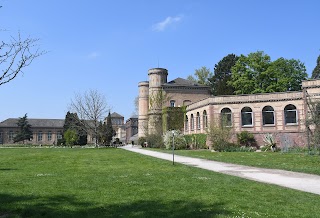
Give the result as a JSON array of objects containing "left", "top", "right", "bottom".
[{"left": 163, "top": 130, "right": 187, "bottom": 150}]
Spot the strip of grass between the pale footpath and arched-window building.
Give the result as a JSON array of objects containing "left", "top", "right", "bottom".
[{"left": 151, "top": 149, "right": 320, "bottom": 175}]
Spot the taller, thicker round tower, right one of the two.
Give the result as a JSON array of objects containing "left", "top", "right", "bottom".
[{"left": 148, "top": 68, "right": 168, "bottom": 134}]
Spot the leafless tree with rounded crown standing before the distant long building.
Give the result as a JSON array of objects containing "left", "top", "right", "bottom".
[{"left": 70, "top": 90, "right": 110, "bottom": 146}]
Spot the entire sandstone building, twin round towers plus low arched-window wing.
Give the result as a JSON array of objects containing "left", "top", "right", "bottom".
[{"left": 138, "top": 68, "right": 320, "bottom": 146}]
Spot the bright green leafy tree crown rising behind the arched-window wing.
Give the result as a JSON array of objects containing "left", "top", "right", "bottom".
[{"left": 228, "top": 51, "right": 307, "bottom": 94}]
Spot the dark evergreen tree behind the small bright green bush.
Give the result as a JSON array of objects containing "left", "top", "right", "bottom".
[{"left": 63, "top": 111, "right": 87, "bottom": 145}]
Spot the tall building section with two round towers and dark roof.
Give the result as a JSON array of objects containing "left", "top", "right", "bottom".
[{"left": 138, "top": 68, "right": 210, "bottom": 137}]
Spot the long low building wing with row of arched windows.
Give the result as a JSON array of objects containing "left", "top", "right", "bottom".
[{"left": 184, "top": 80, "right": 320, "bottom": 146}]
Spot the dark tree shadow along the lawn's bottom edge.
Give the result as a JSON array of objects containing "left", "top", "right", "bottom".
[{"left": 0, "top": 194, "right": 232, "bottom": 218}]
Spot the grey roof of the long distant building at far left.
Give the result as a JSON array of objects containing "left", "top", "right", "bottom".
[{"left": 0, "top": 118, "right": 64, "bottom": 128}]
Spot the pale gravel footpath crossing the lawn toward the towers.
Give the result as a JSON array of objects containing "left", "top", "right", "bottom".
[{"left": 121, "top": 145, "right": 320, "bottom": 195}]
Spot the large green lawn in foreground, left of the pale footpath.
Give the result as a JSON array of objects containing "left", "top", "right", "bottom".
[{"left": 0, "top": 148, "right": 320, "bottom": 218}]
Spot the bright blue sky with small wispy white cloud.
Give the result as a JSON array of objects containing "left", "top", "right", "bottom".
[{"left": 0, "top": 0, "right": 320, "bottom": 121}]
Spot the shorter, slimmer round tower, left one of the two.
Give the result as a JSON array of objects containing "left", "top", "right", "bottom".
[{"left": 138, "top": 81, "right": 149, "bottom": 138}]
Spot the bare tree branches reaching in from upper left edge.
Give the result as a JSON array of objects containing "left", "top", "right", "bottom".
[{"left": 0, "top": 33, "right": 46, "bottom": 85}]
